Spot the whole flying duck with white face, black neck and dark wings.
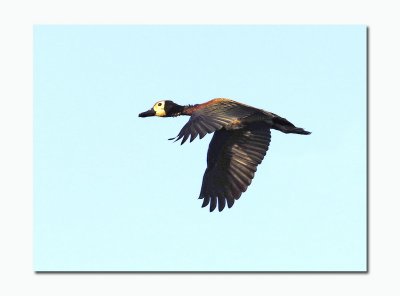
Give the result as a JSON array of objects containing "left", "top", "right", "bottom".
[{"left": 139, "top": 98, "right": 311, "bottom": 212}]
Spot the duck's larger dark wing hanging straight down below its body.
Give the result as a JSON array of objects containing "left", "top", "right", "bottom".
[{"left": 199, "top": 122, "right": 271, "bottom": 212}]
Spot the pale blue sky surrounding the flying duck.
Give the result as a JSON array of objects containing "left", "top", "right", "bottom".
[{"left": 34, "top": 26, "right": 366, "bottom": 271}]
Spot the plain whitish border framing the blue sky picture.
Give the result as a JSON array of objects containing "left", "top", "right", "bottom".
[{"left": 0, "top": 0, "right": 400, "bottom": 296}]
